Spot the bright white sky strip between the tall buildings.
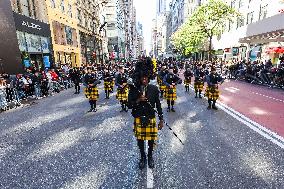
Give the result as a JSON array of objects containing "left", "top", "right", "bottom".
[{"left": 134, "top": 0, "right": 156, "bottom": 53}]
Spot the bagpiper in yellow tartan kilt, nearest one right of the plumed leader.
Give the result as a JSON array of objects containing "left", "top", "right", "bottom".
[{"left": 163, "top": 66, "right": 182, "bottom": 112}]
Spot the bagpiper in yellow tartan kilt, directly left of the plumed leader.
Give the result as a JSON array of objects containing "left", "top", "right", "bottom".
[{"left": 115, "top": 66, "right": 128, "bottom": 112}]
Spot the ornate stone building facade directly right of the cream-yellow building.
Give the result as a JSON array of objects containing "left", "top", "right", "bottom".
[{"left": 76, "top": 0, "right": 108, "bottom": 64}]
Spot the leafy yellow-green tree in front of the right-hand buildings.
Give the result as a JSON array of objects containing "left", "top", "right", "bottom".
[{"left": 172, "top": 0, "right": 240, "bottom": 60}]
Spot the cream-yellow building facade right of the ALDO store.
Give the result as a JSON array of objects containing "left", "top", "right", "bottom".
[{"left": 46, "top": 0, "right": 81, "bottom": 67}]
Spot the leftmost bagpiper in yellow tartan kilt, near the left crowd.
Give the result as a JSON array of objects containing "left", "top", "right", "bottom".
[{"left": 84, "top": 68, "right": 100, "bottom": 112}]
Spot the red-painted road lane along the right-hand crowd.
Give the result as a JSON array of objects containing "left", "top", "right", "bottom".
[{"left": 220, "top": 80, "right": 284, "bottom": 137}]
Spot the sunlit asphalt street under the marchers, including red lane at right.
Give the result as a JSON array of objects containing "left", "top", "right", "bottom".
[{"left": 0, "top": 82, "right": 284, "bottom": 189}]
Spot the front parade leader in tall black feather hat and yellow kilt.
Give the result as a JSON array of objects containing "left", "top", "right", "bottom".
[{"left": 128, "top": 59, "right": 163, "bottom": 169}]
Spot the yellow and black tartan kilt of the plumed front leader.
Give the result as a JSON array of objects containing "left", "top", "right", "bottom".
[{"left": 134, "top": 118, "right": 158, "bottom": 140}]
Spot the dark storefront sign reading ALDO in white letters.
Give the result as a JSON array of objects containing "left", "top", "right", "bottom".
[{"left": 13, "top": 12, "right": 51, "bottom": 37}]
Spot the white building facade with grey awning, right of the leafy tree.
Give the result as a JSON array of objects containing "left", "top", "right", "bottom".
[{"left": 213, "top": 0, "right": 284, "bottom": 63}]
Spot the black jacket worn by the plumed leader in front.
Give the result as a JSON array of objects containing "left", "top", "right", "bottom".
[{"left": 128, "top": 84, "right": 163, "bottom": 120}]
